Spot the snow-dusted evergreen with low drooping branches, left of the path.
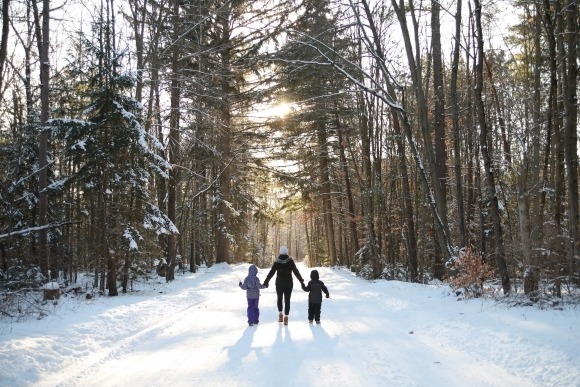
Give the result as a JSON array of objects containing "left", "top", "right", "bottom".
[{"left": 50, "top": 3, "right": 177, "bottom": 296}]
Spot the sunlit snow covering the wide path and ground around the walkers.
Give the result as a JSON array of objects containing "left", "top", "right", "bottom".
[{"left": 0, "top": 263, "right": 580, "bottom": 387}]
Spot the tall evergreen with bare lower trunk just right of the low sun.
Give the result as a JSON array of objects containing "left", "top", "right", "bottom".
[{"left": 276, "top": 1, "right": 351, "bottom": 265}]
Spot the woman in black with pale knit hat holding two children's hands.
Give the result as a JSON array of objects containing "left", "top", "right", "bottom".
[{"left": 264, "top": 246, "right": 304, "bottom": 325}]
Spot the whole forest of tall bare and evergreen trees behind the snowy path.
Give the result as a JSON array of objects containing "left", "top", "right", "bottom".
[{"left": 0, "top": 0, "right": 580, "bottom": 300}]
